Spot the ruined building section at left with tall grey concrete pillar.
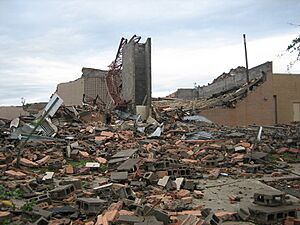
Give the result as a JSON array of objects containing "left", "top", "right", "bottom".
[{"left": 56, "top": 36, "right": 151, "bottom": 118}]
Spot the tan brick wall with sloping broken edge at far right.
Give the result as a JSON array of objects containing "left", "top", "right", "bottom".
[{"left": 201, "top": 62, "right": 300, "bottom": 126}]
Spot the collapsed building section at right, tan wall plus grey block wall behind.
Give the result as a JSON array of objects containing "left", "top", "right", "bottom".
[{"left": 174, "top": 62, "right": 300, "bottom": 126}]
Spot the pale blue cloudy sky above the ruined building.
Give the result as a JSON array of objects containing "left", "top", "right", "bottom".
[{"left": 0, "top": 0, "right": 300, "bottom": 105}]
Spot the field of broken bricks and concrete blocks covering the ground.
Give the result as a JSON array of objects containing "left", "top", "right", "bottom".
[{"left": 0, "top": 96, "right": 300, "bottom": 225}]
